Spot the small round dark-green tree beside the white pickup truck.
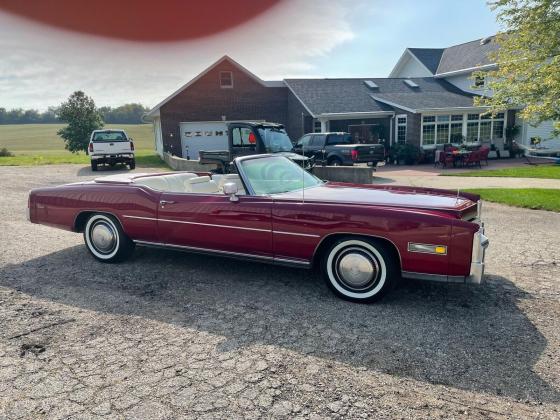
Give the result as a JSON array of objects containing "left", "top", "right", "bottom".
[{"left": 56, "top": 91, "right": 103, "bottom": 153}]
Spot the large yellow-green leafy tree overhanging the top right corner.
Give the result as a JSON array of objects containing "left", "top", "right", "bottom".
[{"left": 473, "top": 0, "right": 560, "bottom": 135}]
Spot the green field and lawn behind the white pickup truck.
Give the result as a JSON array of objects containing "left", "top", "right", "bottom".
[{"left": 0, "top": 124, "right": 167, "bottom": 167}]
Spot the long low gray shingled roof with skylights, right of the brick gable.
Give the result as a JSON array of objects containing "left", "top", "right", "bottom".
[{"left": 284, "top": 77, "right": 473, "bottom": 115}]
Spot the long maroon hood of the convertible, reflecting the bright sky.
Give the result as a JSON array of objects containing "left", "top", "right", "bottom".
[{"left": 273, "top": 182, "right": 479, "bottom": 217}]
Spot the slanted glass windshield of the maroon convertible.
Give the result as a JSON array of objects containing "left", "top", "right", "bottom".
[{"left": 240, "top": 156, "right": 323, "bottom": 195}]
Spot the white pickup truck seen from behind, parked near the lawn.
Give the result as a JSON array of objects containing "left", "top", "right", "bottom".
[{"left": 88, "top": 130, "right": 136, "bottom": 171}]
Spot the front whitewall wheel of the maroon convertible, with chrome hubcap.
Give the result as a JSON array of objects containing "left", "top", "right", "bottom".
[{"left": 322, "top": 237, "right": 399, "bottom": 302}]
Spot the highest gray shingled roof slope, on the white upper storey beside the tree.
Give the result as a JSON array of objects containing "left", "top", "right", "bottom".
[{"left": 436, "top": 36, "right": 499, "bottom": 74}]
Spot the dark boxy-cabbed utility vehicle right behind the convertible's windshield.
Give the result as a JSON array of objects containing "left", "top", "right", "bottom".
[{"left": 199, "top": 122, "right": 313, "bottom": 174}]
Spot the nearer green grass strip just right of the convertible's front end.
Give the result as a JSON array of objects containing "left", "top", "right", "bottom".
[{"left": 465, "top": 188, "right": 560, "bottom": 212}]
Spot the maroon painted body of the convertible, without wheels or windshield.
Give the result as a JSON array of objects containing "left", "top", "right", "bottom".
[{"left": 29, "top": 169, "right": 479, "bottom": 276}]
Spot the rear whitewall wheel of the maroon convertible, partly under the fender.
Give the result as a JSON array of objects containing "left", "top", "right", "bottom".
[{"left": 84, "top": 214, "right": 134, "bottom": 263}]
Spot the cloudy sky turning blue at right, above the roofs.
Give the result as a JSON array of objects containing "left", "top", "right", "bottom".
[{"left": 0, "top": 0, "right": 500, "bottom": 111}]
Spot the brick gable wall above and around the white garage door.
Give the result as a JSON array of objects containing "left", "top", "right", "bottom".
[{"left": 160, "top": 60, "right": 288, "bottom": 156}]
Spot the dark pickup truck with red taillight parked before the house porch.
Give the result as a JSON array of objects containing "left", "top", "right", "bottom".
[{"left": 294, "top": 133, "right": 385, "bottom": 167}]
